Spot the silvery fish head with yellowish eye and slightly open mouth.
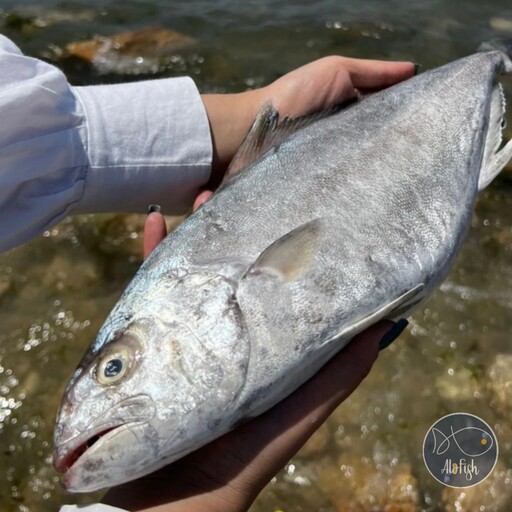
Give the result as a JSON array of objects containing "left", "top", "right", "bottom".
[{"left": 54, "top": 273, "right": 248, "bottom": 492}]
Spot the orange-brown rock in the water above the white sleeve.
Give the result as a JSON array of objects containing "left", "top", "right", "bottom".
[{"left": 66, "top": 26, "right": 195, "bottom": 74}]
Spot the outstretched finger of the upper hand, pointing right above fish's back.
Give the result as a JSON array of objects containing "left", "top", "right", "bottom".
[{"left": 341, "top": 57, "right": 416, "bottom": 89}]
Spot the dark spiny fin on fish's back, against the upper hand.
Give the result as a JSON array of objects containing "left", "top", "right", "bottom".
[{"left": 223, "top": 101, "right": 353, "bottom": 182}]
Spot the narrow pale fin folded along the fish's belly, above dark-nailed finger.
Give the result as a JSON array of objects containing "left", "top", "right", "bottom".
[{"left": 323, "top": 283, "right": 425, "bottom": 345}]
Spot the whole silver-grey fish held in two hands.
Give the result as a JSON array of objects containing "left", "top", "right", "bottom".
[{"left": 54, "top": 45, "right": 512, "bottom": 492}]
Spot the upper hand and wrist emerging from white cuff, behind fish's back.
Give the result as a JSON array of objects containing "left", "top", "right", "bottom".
[{"left": 202, "top": 56, "right": 415, "bottom": 190}]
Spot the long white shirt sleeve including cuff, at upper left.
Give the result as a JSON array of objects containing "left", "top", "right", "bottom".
[{"left": 0, "top": 35, "right": 212, "bottom": 251}]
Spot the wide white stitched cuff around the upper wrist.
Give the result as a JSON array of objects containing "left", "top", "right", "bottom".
[{"left": 73, "top": 78, "right": 212, "bottom": 214}]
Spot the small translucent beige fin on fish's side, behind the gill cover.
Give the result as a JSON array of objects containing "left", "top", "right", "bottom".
[{"left": 243, "top": 219, "right": 322, "bottom": 281}]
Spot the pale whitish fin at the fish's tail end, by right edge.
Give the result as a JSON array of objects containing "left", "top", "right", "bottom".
[{"left": 478, "top": 84, "right": 512, "bottom": 190}]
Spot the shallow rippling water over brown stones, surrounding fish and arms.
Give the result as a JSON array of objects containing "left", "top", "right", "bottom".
[{"left": 0, "top": 0, "right": 512, "bottom": 512}]
